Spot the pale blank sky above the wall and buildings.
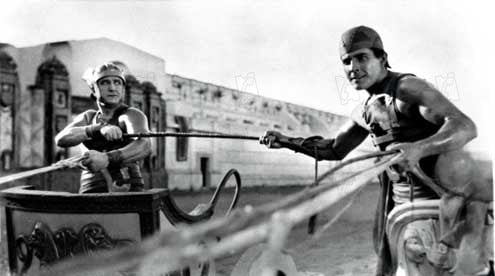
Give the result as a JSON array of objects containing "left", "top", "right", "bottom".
[{"left": 0, "top": 0, "right": 495, "bottom": 156}]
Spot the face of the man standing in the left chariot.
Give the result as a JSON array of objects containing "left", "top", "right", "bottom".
[{"left": 95, "top": 76, "right": 124, "bottom": 105}]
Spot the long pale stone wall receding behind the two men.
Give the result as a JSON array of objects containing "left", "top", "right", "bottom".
[{"left": 164, "top": 75, "right": 376, "bottom": 189}]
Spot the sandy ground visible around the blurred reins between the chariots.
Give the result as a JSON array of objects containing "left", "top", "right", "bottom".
[{"left": 170, "top": 184, "right": 377, "bottom": 276}]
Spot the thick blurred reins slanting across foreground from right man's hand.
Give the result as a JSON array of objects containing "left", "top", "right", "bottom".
[{"left": 43, "top": 151, "right": 403, "bottom": 275}]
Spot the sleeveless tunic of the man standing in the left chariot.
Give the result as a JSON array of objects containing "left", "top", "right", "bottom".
[{"left": 79, "top": 105, "right": 144, "bottom": 193}]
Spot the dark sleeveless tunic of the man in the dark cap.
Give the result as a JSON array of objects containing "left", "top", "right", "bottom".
[{"left": 362, "top": 71, "right": 440, "bottom": 275}]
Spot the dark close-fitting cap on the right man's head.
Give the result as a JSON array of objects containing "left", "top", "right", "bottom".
[{"left": 340, "top": 26, "right": 384, "bottom": 57}]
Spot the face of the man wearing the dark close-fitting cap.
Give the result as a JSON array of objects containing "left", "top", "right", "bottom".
[{"left": 341, "top": 48, "right": 386, "bottom": 90}]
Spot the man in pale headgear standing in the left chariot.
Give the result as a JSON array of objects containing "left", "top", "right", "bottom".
[{"left": 55, "top": 63, "right": 151, "bottom": 193}]
